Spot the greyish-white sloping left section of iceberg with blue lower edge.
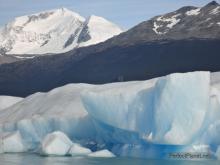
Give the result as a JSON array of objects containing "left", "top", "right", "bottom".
[{"left": 0, "top": 84, "right": 95, "bottom": 150}]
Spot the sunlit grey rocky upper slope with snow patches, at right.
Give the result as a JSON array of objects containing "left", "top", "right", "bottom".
[{"left": 106, "top": 1, "right": 220, "bottom": 48}]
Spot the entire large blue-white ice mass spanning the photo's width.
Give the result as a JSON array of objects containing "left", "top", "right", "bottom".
[{"left": 0, "top": 71, "right": 220, "bottom": 159}]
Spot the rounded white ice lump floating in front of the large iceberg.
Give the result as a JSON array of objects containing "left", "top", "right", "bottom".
[{"left": 41, "top": 131, "right": 73, "bottom": 156}]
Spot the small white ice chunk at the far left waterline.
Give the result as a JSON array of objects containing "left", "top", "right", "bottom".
[{"left": 0, "top": 131, "right": 26, "bottom": 153}]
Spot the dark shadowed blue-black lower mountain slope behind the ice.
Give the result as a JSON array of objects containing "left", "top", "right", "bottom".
[{"left": 0, "top": 40, "right": 220, "bottom": 96}]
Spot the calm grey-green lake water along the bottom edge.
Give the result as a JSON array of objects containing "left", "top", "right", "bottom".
[{"left": 0, "top": 154, "right": 220, "bottom": 165}]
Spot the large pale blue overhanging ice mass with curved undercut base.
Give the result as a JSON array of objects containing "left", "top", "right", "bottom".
[{"left": 82, "top": 72, "right": 210, "bottom": 145}]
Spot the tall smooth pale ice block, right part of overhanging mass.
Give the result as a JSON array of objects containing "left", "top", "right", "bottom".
[{"left": 153, "top": 72, "right": 210, "bottom": 145}]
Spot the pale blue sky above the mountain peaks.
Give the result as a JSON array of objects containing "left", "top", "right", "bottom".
[{"left": 0, "top": 0, "right": 217, "bottom": 30}]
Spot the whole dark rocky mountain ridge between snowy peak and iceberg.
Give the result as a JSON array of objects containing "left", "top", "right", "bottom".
[{"left": 0, "top": 2, "right": 220, "bottom": 96}]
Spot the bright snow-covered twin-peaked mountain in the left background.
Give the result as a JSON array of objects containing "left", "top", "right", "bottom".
[{"left": 0, "top": 8, "right": 122, "bottom": 57}]
